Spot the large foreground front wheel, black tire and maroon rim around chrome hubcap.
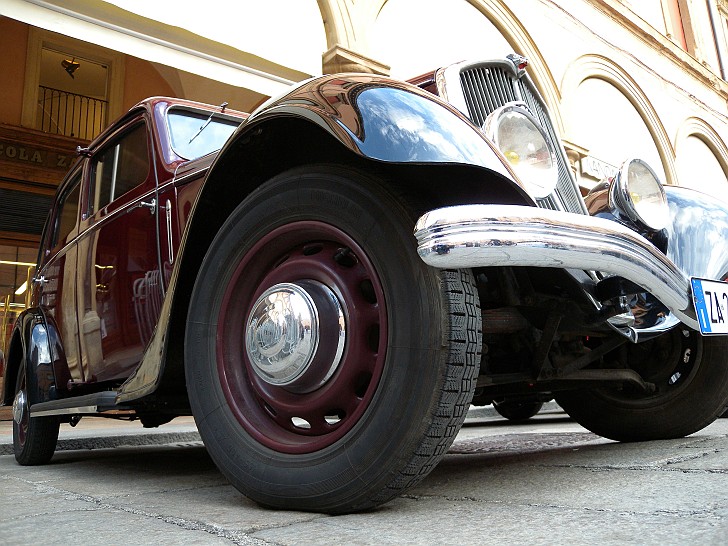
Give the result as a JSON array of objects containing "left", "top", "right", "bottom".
[{"left": 185, "top": 166, "right": 481, "bottom": 513}]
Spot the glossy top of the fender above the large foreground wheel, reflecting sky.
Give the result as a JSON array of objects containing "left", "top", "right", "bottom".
[{"left": 233, "top": 74, "right": 514, "bottom": 180}]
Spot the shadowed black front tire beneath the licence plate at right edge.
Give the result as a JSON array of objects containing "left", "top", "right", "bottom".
[{"left": 556, "top": 327, "right": 728, "bottom": 442}]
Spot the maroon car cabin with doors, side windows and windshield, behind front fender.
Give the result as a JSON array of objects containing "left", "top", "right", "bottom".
[{"left": 13, "top": 98, "right": 247, "bottom": 401}]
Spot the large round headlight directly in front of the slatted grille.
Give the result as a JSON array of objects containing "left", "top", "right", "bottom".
[{"left": 483, "top": 103, "right": 559, "bottom": 198}]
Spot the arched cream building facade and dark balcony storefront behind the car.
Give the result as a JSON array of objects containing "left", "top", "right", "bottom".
[{"left": 0, "top": 0, "right": 728, "bottom": 344}]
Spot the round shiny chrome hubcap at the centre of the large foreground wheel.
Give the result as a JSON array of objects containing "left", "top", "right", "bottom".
[{"left": 245, "top": 280, "right": 346, "bottom": 392}]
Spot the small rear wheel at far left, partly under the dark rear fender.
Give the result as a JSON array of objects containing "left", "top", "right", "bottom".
[{"left": 13, "top": 363, "right": 60, "bottom": 466}]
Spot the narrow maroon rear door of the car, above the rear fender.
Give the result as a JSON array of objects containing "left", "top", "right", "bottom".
[{"left": 34, "top": 166, "right": 85, "bottom": 386}]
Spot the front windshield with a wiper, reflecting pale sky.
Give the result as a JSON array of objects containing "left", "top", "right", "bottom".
[{"left": 167, "top": 108, "right": 242, "bottom": 159}]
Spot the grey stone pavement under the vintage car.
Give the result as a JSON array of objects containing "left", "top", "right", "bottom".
[{"left": 0, "top": 402, "right": 728, "bottom": 546}]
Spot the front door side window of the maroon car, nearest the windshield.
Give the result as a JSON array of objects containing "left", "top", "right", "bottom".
[{"left": 89, "top": 123, "right": 149, "bottom": 214}]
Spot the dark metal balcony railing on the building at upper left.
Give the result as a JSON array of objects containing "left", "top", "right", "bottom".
[{"left": 36, "top": 85, "right": 108, "bottom": 140}]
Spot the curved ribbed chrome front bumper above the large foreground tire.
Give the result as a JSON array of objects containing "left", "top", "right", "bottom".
[{"left": 415, "top": 205, "right": 699, "bottom": 330}]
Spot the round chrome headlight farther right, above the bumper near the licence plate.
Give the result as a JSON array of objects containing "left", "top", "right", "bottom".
[{"left": 609, "top": 159, "right": 670, "bottom": 231}]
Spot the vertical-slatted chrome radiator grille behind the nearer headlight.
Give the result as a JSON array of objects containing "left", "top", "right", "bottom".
[{"left": 456, "top": 61, "right": 586, "bottom": 214}]
